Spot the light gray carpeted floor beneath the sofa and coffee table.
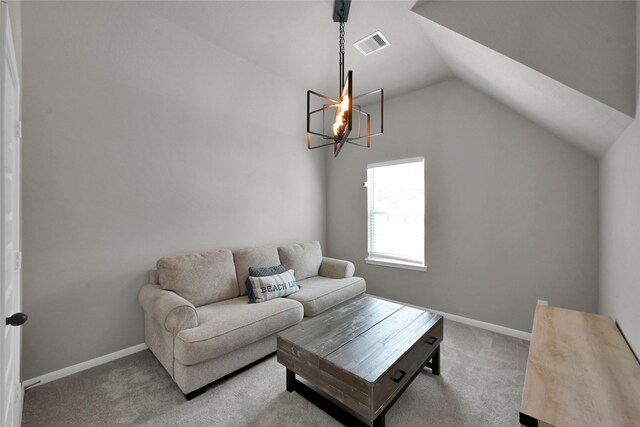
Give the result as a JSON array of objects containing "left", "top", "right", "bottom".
[{"left": 23, "top": 320, "right": 529, "bottom": 427}]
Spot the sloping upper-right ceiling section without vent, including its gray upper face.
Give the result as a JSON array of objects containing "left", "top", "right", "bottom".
[{"left": 413, "top": 0, "right": 636, "bottom": 158}]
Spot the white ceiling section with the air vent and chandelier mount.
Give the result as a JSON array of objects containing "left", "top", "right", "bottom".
[{"left": 136, "top": 0, "right": 451, "bottom": 102}]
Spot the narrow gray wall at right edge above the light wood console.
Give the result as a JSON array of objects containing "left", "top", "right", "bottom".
[{"left": 600, "top": 8, "right": 640, "bottom": 355}]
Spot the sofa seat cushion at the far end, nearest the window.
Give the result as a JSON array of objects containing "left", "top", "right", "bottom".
[{"left": 287, "top": 276, "right": 367, "bottom": 317}]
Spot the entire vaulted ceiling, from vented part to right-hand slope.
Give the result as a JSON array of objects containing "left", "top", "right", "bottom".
[{"left": 138, "top": 0, "right": 636, "bottom": 158}]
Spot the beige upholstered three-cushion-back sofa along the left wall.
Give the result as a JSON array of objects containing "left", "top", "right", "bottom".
[{"left": 138, "top": 242, "right": 366, "bottom": 398}]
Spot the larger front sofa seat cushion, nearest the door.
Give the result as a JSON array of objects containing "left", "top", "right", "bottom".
[{"left": 174, "top": 296, "right": 304, "bottom": 366}]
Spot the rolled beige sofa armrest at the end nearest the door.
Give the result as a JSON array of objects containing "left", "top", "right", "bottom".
[{"left": 138, "top": 283, "right": 198, "bottom": 335}]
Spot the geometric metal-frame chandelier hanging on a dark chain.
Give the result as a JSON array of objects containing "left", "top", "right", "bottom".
[{"left": 307, "top": 0, "right": 384, "bottom": 157}]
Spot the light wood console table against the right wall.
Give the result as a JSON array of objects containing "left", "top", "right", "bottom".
[{"left": 520, "top": 305, "right": 640, "bottom": 427}]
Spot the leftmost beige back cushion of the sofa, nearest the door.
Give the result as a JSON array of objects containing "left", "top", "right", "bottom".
[{"left": 156, "top": 249, "right": 238, "bottom": 307}]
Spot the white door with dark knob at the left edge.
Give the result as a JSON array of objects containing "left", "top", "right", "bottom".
[{"left": 0, "top": 2, "right": 26, "bottom": 427}]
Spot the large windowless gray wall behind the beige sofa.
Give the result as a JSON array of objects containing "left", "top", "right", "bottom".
[{"left": 22, "top": 2, "right": 326, "bottom": 379}]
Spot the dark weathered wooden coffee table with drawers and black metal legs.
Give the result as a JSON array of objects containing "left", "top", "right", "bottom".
[{"left": 277, "top": 296, "right": 443, "bottom": 426}]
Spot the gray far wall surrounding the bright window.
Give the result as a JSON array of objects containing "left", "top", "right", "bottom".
[{"left": 327, "top": 80, "right": 598, "bottom": 331}]
